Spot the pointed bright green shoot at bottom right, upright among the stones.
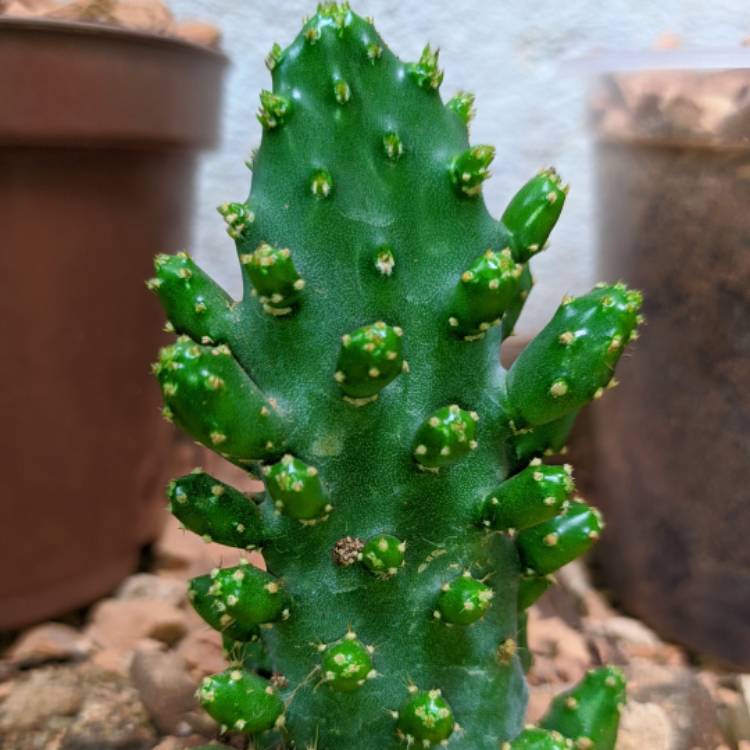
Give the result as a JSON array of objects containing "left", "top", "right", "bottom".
[{"left": 541, "top": 667, "right": 626, "bottom": 750}]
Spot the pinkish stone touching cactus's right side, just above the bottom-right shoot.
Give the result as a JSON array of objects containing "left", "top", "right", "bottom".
[{"left": 528, "top": 607, "right": 591, "bottom": 684}]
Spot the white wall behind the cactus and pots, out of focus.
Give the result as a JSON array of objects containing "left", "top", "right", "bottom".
[{"left": 170, "top": 0, "right": 750, "bottom": 335}]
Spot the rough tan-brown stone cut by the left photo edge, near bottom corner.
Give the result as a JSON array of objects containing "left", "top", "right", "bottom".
[{"left": 0, "top": 667, "right": 84, "bottom": 732}]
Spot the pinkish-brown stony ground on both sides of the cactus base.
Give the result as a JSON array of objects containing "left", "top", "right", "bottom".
[{"left": 0, "top": 446, "right": 750, "bottom": 750}]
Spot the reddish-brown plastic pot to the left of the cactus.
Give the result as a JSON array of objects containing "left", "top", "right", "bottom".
[{"left": 0, "top": 19, "right": 225, "bottom": 628}]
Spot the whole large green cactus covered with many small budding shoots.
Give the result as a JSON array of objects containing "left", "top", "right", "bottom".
[{"left": 148, "top": 3, "right": 640, "bottom": 750}]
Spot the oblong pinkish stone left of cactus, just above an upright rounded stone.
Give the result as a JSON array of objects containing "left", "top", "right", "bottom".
[{"left": 86, "top": 599, "right": 187, "bottom": 651}]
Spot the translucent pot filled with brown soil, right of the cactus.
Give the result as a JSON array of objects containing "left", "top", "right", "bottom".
[{"left": 593, "top": 63, "right": 750, "bottom": 670}]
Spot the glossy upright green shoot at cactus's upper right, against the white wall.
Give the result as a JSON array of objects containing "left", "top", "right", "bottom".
[{"left": 502, "top": 168, "right": 568, "bottom": 263}]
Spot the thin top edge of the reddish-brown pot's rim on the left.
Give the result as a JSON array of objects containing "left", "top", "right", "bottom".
[{"left": 0, "top": 16, "right": 229, "bottom": 65}]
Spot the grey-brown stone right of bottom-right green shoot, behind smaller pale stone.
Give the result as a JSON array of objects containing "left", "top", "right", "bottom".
[{"left": 625, "top": 658, "right": 723, "bottom": 750}]
